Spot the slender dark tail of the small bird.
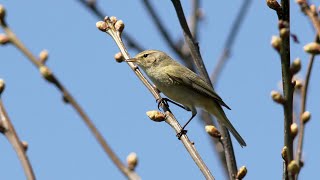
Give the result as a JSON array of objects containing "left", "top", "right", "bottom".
[{"left": 210, "top": 104, "right": 247, "bottom": 146}]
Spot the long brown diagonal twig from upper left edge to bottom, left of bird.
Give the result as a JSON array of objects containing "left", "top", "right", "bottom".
[{"left": 0, "top": 11, "right": 140, "bottom": 180}]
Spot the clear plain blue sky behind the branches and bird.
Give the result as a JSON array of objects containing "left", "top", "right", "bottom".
[{"left": 0, "top": 0, "right": 320, "bottom": 180}]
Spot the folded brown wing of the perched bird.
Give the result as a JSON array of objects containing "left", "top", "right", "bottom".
[{"left": 166, "top": 69, "right": 231, "bottom": 110}]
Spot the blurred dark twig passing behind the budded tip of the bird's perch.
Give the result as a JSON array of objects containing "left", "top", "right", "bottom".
[{"left": 78, "top": 0, "right": 145, "bottom": 52}]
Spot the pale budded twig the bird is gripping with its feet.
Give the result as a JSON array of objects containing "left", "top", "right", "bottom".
[{"left": 97, "top": 17, "right": 214, "bottom": 179}]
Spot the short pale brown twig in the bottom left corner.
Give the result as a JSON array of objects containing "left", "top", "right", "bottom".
[{"left": 0, "top": 99, "right": 36, "bottom": 180}]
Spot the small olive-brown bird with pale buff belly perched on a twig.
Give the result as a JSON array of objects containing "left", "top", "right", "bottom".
[{"left": 126, "top": 50, "right": 246, "bottom": 146}]
